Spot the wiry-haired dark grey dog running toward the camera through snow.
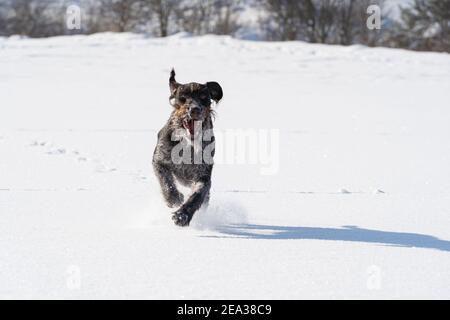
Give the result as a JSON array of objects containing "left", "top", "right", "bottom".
[{"left": 153, "top": 70, "right": 223, "bottom": 226}]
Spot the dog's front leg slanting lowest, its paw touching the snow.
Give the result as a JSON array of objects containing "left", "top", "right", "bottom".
[{"left": 172, "top": 180, "right": 211, "bottom": 227}]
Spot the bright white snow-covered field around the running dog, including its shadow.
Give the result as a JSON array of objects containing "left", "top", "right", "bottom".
[{"left": 0, "top": 34, "right": 450, "bottom": 299}]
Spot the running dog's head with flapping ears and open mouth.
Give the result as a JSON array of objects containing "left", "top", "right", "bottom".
[{"left": 169, "top": 69, "right": 223, "bottom": 136}]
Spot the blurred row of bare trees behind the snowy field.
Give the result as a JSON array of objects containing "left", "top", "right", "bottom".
[{"left": 0, "top": 0, "right": 450, "bottom": 52}]
